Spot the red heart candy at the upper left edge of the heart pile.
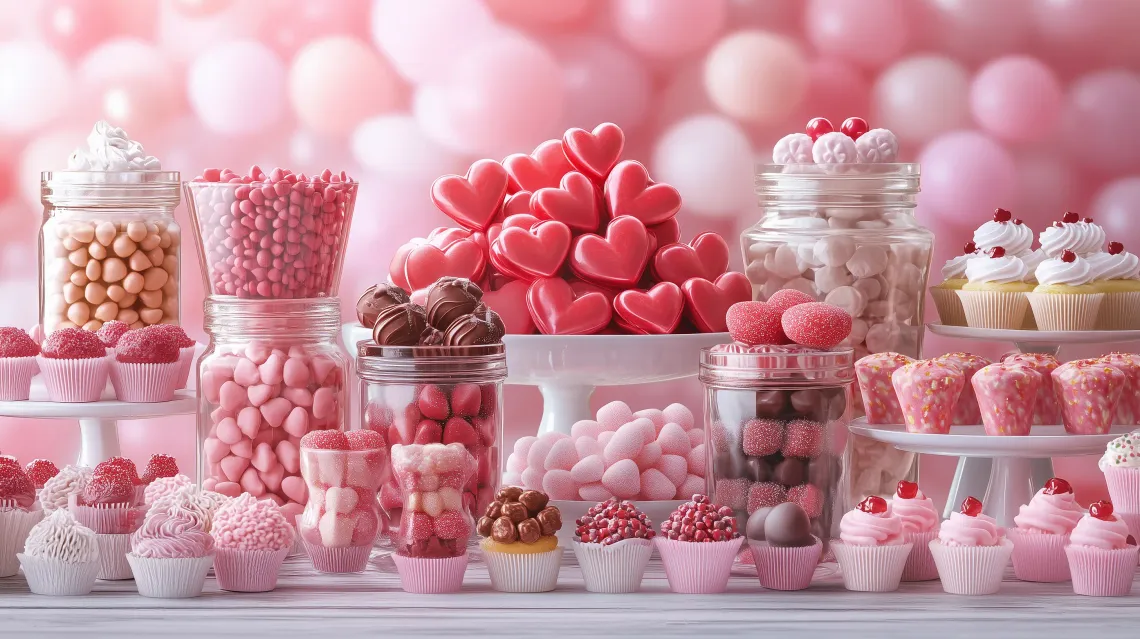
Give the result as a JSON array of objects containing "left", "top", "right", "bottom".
[{"left": 431, "top": 159, "right": 507, "bottom": 231}]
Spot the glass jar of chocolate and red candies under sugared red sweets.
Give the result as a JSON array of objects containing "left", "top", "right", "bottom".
[{"left": 700, "top": 345, "right": 855, "bottom": 544}]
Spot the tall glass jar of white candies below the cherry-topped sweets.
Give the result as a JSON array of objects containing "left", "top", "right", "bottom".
[{"left": 741, "top": 164, "right": 934, "bottom": 508}]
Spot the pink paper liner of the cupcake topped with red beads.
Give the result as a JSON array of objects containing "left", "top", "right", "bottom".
[{"left": 653, "top": 536, "right": 744, "bottom": 595}]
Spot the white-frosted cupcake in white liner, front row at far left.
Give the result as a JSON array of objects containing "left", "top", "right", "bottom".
[{"left": 18, "top": 509, "right": 99, "bottom": 596}]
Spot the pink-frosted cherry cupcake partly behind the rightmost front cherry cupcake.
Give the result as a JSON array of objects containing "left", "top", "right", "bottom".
[{"left": 1007, "top": 477, "right": 1084, "bottom": 582}]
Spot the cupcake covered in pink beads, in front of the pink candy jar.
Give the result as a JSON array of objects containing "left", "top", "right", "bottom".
[{"left": 210, "top": 492, "right": 295, "bottom": 592}]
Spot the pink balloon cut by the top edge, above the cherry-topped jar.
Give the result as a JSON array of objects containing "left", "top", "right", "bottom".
[{"left": 806, "top": 0, "right": 907, "bottom": 67}]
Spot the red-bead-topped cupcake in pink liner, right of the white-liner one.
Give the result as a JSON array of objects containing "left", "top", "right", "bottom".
[{"left": 653, "top": 494, "right": 744, "bottom": 595}]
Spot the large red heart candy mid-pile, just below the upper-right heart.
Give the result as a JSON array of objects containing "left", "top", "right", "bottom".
[{"left": 570, "top": 218, "right": 650, "bottom": 288}]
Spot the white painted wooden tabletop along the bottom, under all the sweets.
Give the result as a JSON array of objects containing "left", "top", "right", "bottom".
[{"left": 0, "top": 552, "right": 1140, "bottom": 639}]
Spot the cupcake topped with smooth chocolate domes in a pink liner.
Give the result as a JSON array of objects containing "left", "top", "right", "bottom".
[{"left": 744, "top": 501, "right": 823, "bottom": 590}]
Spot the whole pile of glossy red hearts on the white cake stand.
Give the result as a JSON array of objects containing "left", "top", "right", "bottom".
[{"left": 389, "top": 123, "right": 751, "bottom": 335}]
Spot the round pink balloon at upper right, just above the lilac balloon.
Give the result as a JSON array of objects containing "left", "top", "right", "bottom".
[{"left": 970, "top": 56, "right": 1061, "bottom": 142}]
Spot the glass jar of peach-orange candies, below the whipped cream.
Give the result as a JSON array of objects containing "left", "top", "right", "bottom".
[{"left": 40, "top": 171, "right": 182, "bottom": 334}]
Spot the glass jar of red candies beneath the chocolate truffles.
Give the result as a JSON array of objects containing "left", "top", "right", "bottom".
[{"left": 357, "top": 341, "right": 506, "bottom": 543}]
